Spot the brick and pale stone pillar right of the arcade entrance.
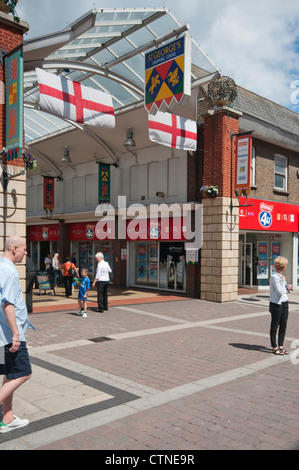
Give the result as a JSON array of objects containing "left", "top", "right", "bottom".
[{"left": 201, "top": 107, "right": 241, "bottom": 302}]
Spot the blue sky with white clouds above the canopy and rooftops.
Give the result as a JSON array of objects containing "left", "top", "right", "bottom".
[{"left": 17, "top": 0, "right": 299, "bottom": 112}]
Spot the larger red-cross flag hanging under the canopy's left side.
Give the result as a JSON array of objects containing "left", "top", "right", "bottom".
[{"left": 36, "top": 69, "right": 115, "bottom": 129}]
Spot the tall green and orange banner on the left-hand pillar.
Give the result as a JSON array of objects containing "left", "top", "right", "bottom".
[{"left": 5, "top": 48, "right": 24, "bottom": 167}]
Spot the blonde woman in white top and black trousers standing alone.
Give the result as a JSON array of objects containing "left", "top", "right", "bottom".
[{"left": 270, "top": 256, "right": 292, "bottom": 355}]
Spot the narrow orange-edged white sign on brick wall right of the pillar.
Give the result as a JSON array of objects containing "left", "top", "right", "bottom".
[{"left": 235, "top": 134, "right": 252, "bottom": 196}]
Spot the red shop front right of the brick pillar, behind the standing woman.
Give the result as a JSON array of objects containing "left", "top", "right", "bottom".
[{"left": 239, "top": 198, "right": 299, "bottom": 288}]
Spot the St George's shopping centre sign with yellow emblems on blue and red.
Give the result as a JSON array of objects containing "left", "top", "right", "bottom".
[{"left": 145, "top": 35, "right": 191, "bottom": 114}]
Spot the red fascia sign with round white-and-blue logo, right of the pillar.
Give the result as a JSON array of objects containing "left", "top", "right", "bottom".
[{"left": 239, "top": 198, "right": 299, "bottom": 233}]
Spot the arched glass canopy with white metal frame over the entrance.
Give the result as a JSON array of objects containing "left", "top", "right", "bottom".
[{"left": 24, "top": 8, "right": 218, "bottom": 143}]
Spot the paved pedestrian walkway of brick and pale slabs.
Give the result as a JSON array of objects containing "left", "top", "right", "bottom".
[{"left": 0, "top": 290, "right": 299, "bottom": 454}]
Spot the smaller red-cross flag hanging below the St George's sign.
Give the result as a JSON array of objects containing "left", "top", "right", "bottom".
[{"left": 148, "top": 111, "right": 197, "bottom": 151}]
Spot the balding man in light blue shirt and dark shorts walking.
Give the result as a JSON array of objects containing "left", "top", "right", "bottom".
[{"left": 0, "top": 235, "right": 33, "bottom": 433}]
